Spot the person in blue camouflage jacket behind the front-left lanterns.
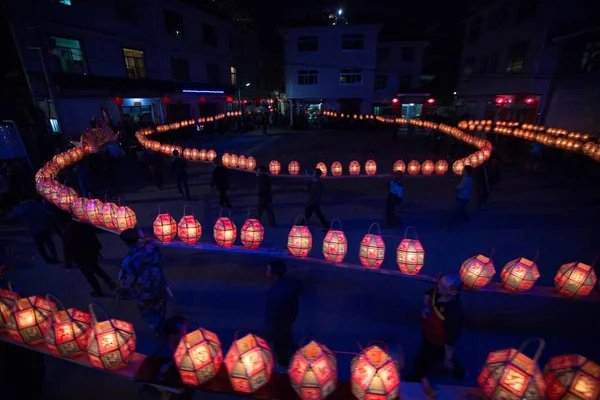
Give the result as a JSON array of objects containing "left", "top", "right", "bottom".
[{"left": 118, "top": 229, "right": 169, "bottom": 335}]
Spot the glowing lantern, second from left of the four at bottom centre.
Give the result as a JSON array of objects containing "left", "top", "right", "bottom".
[{"left": 225, "top": 333, "right": 273, "bottom": 393}]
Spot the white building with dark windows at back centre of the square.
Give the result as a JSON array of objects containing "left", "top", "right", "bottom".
[{"left": 281, "top": 24, "right": 426, "bottom": 114}]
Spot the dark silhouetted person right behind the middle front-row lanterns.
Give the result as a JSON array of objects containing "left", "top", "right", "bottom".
[{"left": 265, "top": 260, "right": 302, "bottom": 368}]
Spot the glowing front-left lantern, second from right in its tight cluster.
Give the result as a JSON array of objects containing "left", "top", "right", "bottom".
[{"left": 44, "top": 299, "right": 92, "bottom": 357}]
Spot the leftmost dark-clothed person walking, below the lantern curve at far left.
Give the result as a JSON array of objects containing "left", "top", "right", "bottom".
[{"left": 8, "top": 195, "right": 58, "bottom": 264}]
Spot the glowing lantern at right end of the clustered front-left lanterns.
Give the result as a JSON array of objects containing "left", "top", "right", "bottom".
[{"left": 87, "top": 304, "right": 136, "bottom": 371}]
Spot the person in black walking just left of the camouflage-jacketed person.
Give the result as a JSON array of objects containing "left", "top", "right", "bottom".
[{"left": 63, "top": 221, "right": 117, "bottom": 297}]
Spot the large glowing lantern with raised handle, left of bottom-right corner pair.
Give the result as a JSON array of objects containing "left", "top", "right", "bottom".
[{"left": 477, "top": 345, "right": 546, "bottom": 400}]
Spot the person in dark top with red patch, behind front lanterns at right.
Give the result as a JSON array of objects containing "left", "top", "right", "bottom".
[{"left": 406, "top": 275, "right": 465, "bottom": 399}]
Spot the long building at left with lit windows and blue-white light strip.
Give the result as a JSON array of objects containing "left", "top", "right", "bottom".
[{"left": 8, "top": 0, "right": 268, "bottom": 135}]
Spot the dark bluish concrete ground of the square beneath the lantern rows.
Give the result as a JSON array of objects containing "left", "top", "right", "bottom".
[{"left": 0, "top": 126, "right": 600, "bottom": 400}]
